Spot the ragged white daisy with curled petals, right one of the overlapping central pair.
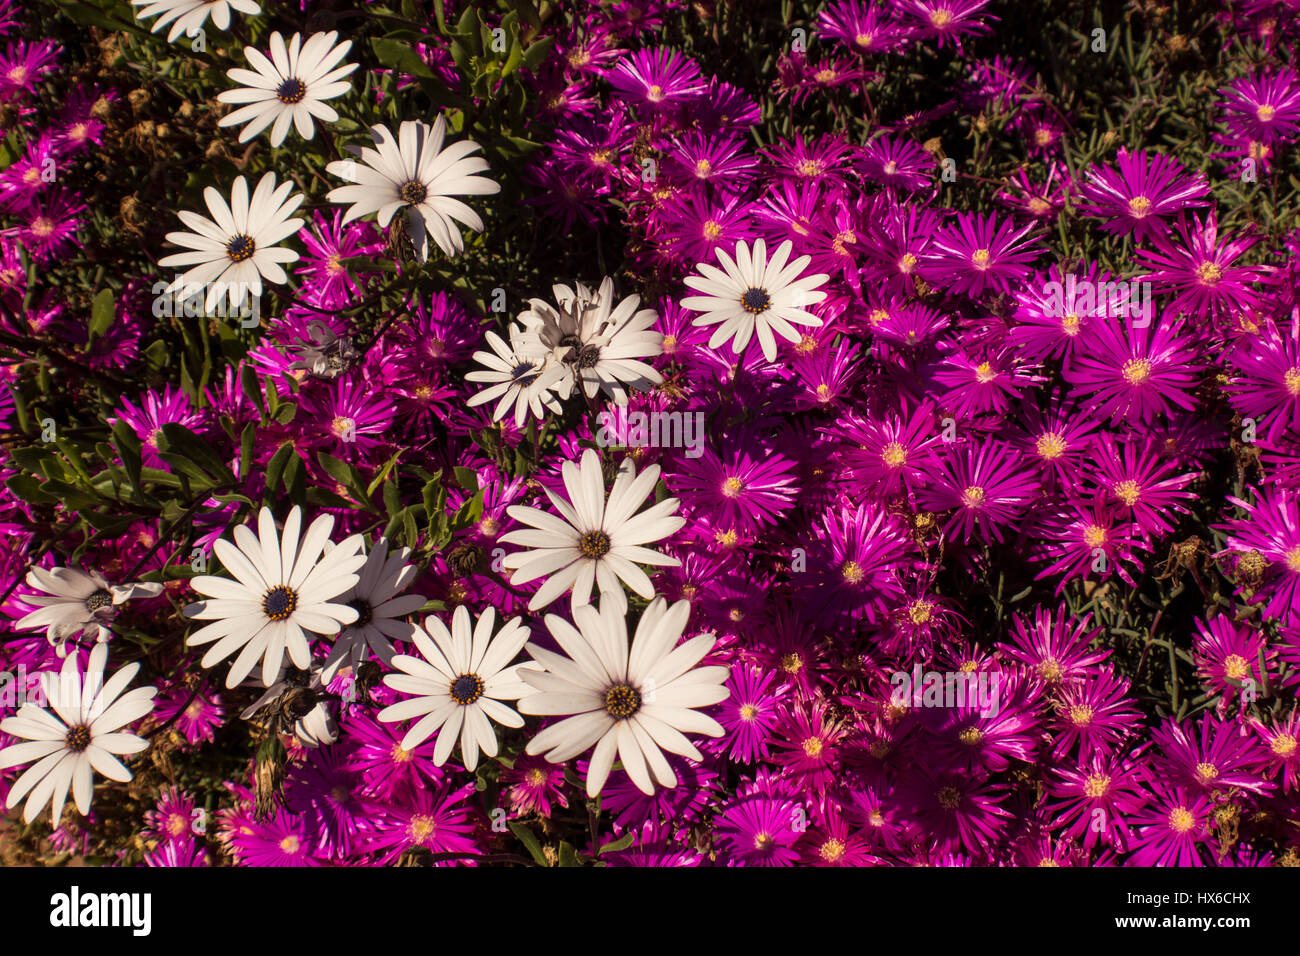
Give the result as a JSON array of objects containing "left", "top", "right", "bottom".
[{"left": 519, "top": 277, "right": 663, "bottom": 405}]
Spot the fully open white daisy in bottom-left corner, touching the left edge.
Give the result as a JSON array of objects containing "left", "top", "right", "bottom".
[{"left": 0, "top": 644, "right": 157, "bottom": 826}]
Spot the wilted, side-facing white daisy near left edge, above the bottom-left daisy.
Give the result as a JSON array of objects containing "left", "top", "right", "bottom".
[{"left": 14, "top": 567, "right": 163, "bottom": 657}]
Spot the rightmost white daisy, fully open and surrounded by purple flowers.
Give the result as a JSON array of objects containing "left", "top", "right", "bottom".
[{"left": 681, "top": 239, "right": 829, "bottom": 362}]
